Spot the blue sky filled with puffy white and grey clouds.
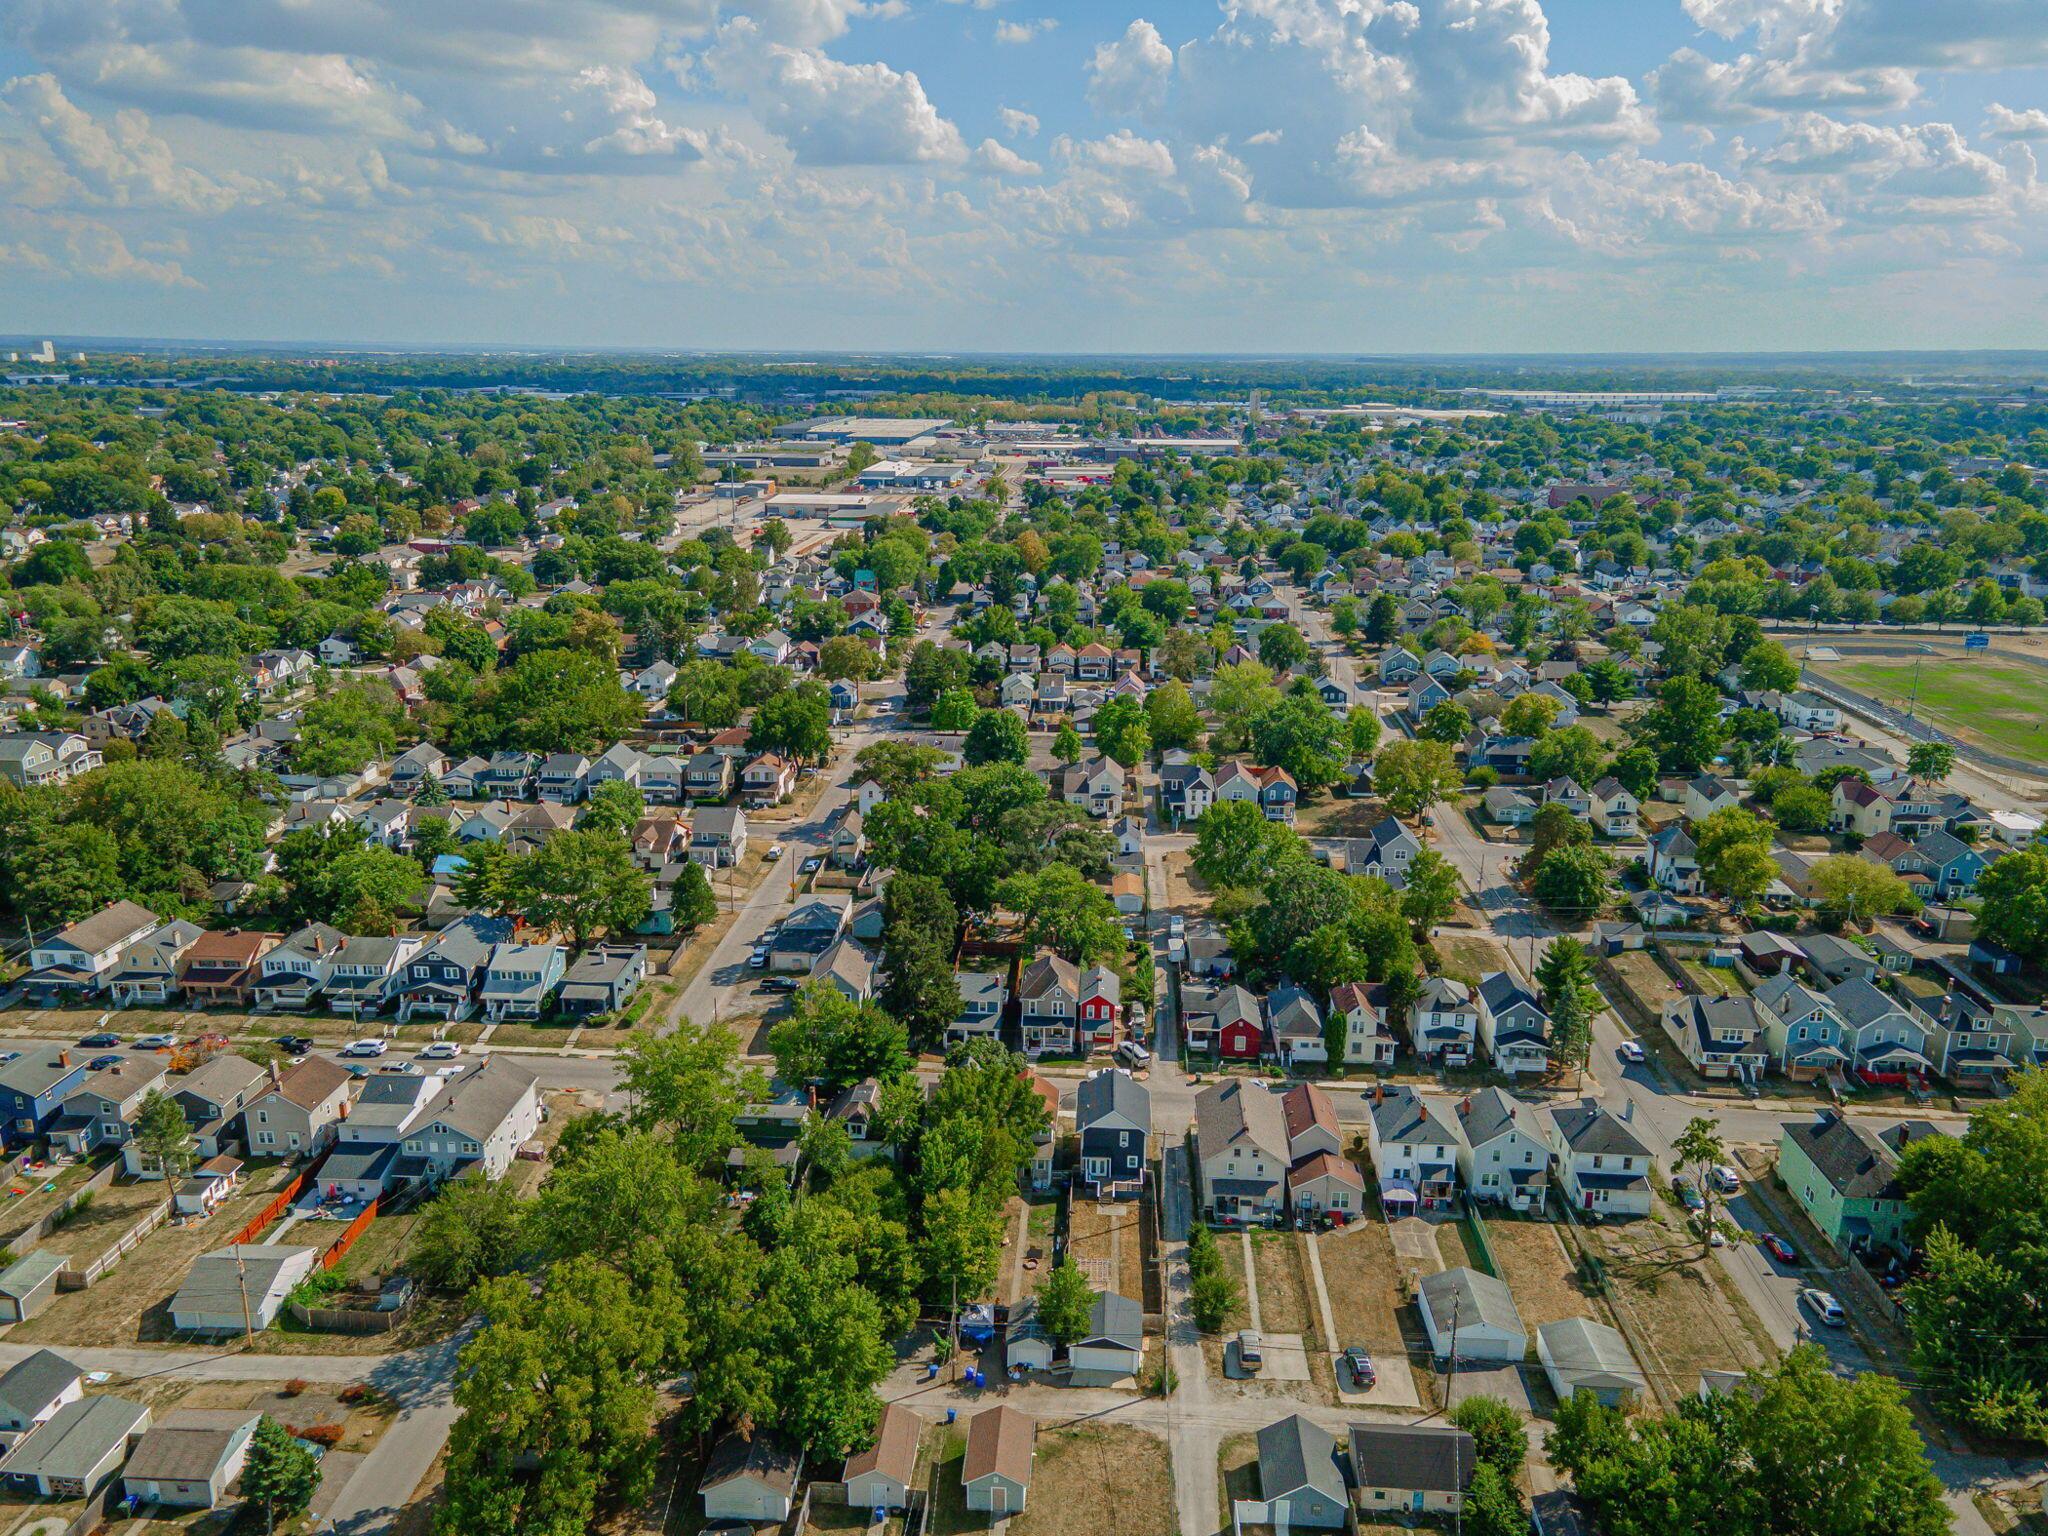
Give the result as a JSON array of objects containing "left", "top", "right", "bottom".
[{"left": 0, "top": 0, "right": 2048, "bottom": 354}]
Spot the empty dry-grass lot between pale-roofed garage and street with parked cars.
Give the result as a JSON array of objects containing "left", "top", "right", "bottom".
[{"left": 1589, "top": 1212, "right": 1772, "bottom": 1403}]
